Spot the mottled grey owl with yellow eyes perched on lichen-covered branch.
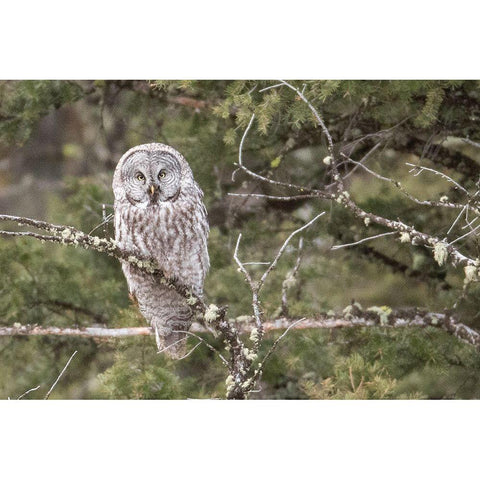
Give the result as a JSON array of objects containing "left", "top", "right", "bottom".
[{"left": 112, "top": 143, "right": 209, "bottom": 358}]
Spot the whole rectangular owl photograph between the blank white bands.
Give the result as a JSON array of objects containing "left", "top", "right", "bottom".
[{"left": 0, "top": 79, "right": 480, "bottom": 400}]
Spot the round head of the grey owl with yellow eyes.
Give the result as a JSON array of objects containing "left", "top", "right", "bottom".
[{"left": 112, "top": 143, "right": 193, "bottom": 208}]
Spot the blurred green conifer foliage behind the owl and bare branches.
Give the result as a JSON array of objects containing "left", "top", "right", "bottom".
[{"left": 0, "top": 80, "right": 480, "bottom": 399}]
